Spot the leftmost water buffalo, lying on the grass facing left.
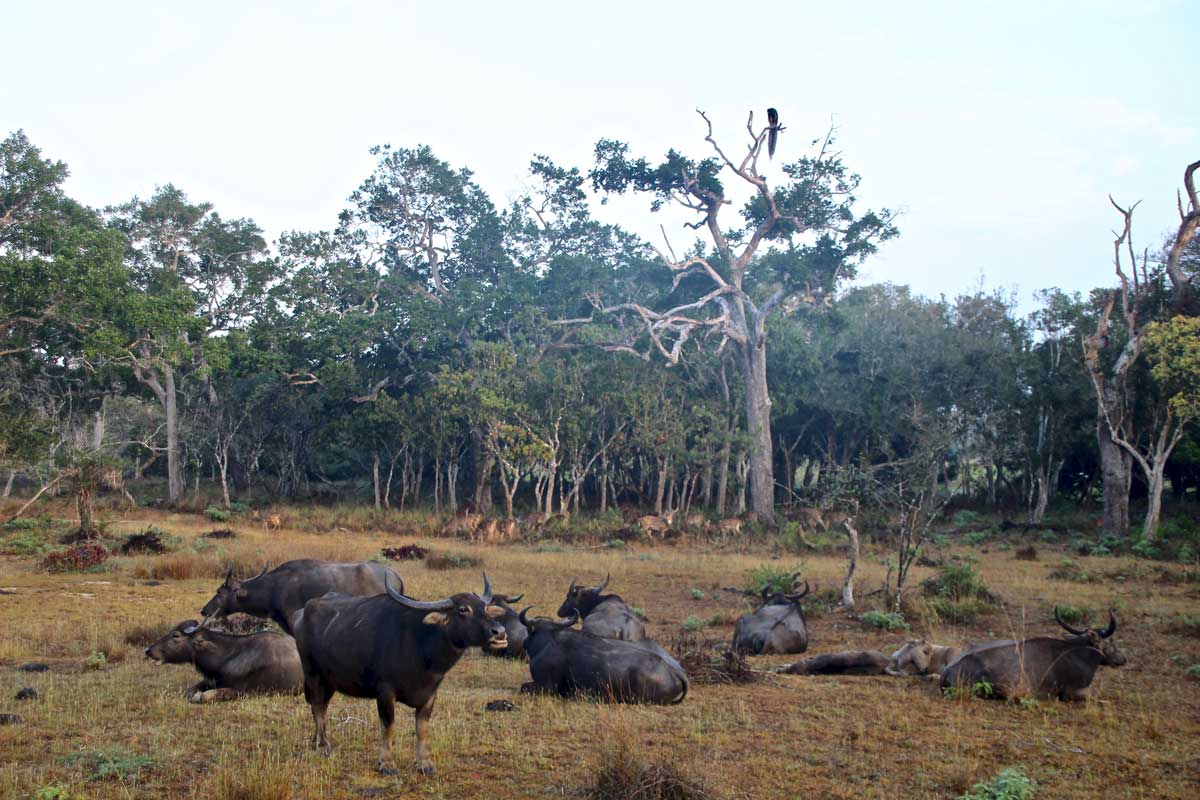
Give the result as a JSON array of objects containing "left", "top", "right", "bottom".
[{"left": 145, "top": 619, "right": 304, "bottom": 703}]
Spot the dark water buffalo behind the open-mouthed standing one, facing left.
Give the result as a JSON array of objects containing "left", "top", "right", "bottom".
[{"left": 200, "top": 559, "right": 404, "bottom": 633}]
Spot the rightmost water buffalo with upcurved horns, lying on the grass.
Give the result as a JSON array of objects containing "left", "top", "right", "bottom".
[{"left": 941, "top": 608, "right": 1126, "bottom": 700}]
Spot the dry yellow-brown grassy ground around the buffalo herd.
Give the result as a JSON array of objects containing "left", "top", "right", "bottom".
[{"left": 0, "top": 506, "right": 1200, "bottom": 800}]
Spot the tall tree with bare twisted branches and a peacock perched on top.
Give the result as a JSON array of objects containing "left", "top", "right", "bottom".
[{"left": 576, "top": 113, "right": 896, "bottom": 522}]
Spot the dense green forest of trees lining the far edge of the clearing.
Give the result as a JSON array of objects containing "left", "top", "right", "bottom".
[{"left": 0, "top": 122, "right": 1200, "bottom": 541}]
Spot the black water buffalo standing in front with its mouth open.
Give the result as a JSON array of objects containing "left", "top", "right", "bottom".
[{"left": 296, "top": 575, "right": 505, "bottom": 775}]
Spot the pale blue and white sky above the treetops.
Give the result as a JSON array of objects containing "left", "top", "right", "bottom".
[{"left": 0, "top": 0, "right": 1200, "bottom": 307}]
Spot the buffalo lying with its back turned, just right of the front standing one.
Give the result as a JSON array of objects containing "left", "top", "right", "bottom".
[{"left": 520, "top": 608, "right": 689, "bottom": 705}]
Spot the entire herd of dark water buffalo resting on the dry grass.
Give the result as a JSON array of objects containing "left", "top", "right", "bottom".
[{"left": 145, "top": 559, "right": 1126, "bottom": 774}]
